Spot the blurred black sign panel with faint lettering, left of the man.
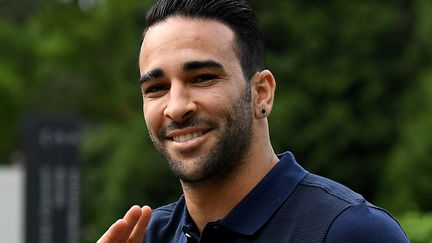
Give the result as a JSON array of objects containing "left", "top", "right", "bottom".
[{"left": 23, "top": 115, "right": 80, "bottom": 243}]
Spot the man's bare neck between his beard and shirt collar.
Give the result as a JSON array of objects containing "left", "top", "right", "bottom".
[{"left": 182, "top": 143, "right": 278, "bottom": 232}]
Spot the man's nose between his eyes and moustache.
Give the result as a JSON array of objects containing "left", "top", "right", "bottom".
[{"left": 164, "top": 83, "right": 197, "bottom": 122}]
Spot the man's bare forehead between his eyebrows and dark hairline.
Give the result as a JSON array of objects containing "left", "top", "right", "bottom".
[{"left": 139, "top": 16, "right": 238, "bottom": 71}]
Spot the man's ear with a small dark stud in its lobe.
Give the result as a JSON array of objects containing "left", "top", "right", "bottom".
[{"left": 251, "top": 70, "right": 276, "bottom": 119}]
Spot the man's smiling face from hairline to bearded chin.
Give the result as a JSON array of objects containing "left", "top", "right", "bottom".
[{"left": 139, "top": 17, "right": 253, "bottom": 183}]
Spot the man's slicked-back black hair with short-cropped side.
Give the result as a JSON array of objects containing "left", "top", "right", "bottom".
[{"left": 144, "top": 0, "right": 265, "bottom": 80}]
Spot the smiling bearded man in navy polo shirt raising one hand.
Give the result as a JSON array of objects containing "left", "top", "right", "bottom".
[{"left": 99, "top": 0, "right": 408, "bottom": 242}]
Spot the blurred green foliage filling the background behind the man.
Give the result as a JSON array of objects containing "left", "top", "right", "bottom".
[{"left": 0, "top": 0, "right": 432, "bottom": 242}]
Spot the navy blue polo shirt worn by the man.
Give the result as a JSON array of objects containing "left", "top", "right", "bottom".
[{"left": 143, "top": 152, "right": 409, "bottom": 243}]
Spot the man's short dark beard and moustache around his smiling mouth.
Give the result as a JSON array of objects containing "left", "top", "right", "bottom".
[{"left": 149, "top": 84, "right": 253, "bottom": 186}]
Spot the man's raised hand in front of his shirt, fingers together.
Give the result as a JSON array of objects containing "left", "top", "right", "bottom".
[{"left": 97, "top": 206, "right": 151, "bottom": 243}]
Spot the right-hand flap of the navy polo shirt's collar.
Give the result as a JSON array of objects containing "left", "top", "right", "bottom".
[{"left": 219, "top": 152, "right": 308, "bottom": 235}]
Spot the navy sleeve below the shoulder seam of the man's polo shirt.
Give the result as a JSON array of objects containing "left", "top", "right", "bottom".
[{"left": 325, "top": 204, "right": 409, "bottom": 243}]
